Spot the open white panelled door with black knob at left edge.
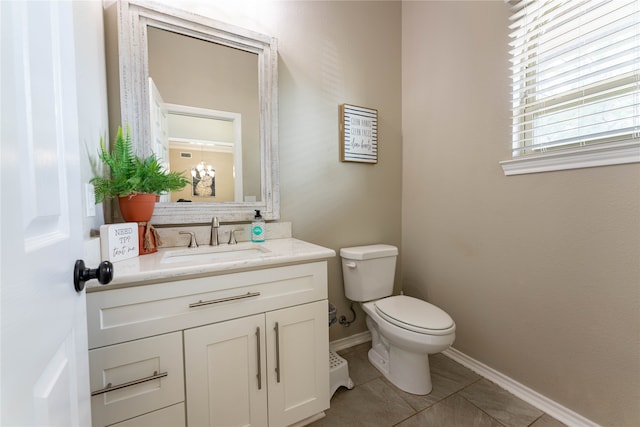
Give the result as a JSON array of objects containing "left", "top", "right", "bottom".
[{"left": 0, "top": 1, "right": 95, "bottom": 426}]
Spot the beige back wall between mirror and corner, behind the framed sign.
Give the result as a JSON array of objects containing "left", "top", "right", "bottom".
[{"left": 267, "top": 1, "right": 402, "bottom": 340}]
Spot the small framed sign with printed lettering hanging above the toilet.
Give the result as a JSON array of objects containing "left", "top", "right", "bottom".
[{"left": 340, "top": 104, "right": 378, "bottom": 163}]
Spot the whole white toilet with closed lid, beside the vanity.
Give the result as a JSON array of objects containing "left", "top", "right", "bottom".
[{"left": 340, "top": 245, "right": 456, "bottom": 394}]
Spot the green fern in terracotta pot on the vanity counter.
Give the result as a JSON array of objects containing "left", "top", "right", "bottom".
[{"left": 91, "top": 127, "right": 189, "bottom": 253}]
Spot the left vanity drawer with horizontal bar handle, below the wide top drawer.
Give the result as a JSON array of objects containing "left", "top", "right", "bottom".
[{"left": 89, "top": 332, "right": 184, "bottom": 427}]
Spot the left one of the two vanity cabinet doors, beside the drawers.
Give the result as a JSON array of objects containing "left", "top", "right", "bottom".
[{"left": 184, "top": 314, "right": 267, "bottom": 427}]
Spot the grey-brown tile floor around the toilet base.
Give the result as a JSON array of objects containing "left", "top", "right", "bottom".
[{"left": 311, "top": 343, "right": 564, "bottom": 427}]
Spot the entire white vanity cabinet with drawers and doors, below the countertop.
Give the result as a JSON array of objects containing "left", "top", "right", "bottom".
[{"left": 87, "top": 261, "right": 329, "bottom": 427}]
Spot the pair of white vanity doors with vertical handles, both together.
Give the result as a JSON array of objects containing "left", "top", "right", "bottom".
[{"left": 184, "top": 301, "right": 329, "bottom": 427}]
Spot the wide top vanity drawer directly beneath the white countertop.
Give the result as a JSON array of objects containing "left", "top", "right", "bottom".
[{"left": 87, "top": 261, "right": 327, "bottom": 348}]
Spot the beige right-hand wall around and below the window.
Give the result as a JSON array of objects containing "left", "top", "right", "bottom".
[{"left": 402, "top": 2, "right": 640, "bottom": 426}]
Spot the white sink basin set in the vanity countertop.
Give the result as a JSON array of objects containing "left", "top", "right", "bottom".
[{"left": 161, "top": 244, "right": 271, "bottom": 264}]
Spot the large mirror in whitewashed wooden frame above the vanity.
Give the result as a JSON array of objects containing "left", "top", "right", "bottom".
[{"left": 117, "top": 0, "right": 280, "bottom": 224}]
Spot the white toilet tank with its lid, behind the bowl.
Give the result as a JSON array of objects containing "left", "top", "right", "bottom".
[{"left": 340, "top": 245, "right": 398, "bottom": 301}]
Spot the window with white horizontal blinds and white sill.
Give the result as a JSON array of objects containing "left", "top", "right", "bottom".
[{"left": 501, "top": 0, "right": 640, "bottom": 175}]
